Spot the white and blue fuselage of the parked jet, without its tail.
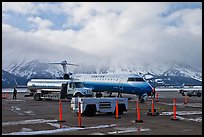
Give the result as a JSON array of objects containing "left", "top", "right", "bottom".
[{"left": 72, "top": 74, "right": 152, "bottom": 95}]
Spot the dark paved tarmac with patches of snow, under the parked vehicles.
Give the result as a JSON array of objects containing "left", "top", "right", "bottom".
[{"left": 2, "top": 92, "right": 202, "bottom": 135}]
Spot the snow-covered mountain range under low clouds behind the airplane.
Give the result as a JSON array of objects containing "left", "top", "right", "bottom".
[{"left": 2, "top": 60, "right": 202, "bottom": 87}]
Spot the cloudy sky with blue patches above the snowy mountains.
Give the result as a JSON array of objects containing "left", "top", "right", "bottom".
[{"left": 2, "top": 2, "right": 202, "bottom": 69}]
